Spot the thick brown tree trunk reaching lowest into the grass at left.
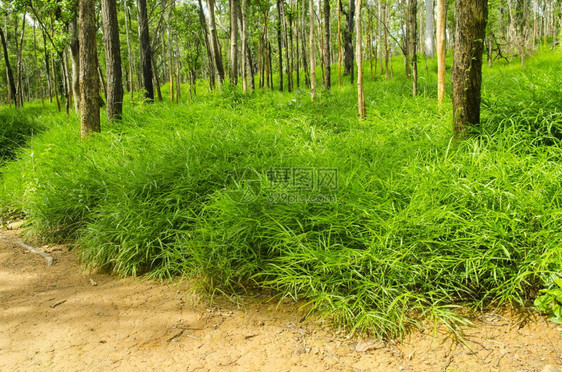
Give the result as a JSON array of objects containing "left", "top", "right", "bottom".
[{"left": 78, "top": 0, "right": 100, "bottom": 137}]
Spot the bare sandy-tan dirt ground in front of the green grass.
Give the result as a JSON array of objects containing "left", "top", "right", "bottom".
[{"left": 0, "top": 230, "right": 562, "bottom": 372}]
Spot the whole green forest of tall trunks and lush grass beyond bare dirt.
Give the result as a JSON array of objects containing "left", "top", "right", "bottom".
[{"left": 0, "top": 0, "right": 562, "bottom": 346}]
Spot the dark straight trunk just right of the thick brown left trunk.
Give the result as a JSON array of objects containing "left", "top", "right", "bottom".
[{"left": 101, "top": 0, "right": 123, "bottom": 120}]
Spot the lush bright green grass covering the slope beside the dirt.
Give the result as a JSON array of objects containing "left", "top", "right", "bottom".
[{"left": 0, "top": 53, "right": 562, "bottom": 338}]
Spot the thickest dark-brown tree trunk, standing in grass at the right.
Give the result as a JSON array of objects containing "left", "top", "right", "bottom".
[{"left": 452, "top": 0, "right": 488, "bottom": 136}]
